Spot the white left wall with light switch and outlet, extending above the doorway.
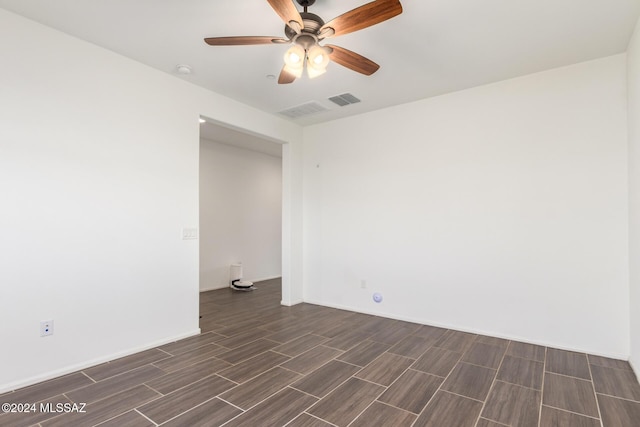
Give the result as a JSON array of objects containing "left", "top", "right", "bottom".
[{"left": 0, "top": 9, "right": 302, "bottom": 392}]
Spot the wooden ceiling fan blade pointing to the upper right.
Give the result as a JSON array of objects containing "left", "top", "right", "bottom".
[{"left": 319, "top": 0, "right": 402, "bottom": 37}]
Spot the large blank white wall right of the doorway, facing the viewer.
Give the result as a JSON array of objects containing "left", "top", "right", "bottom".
[{"left": 304, "top": 54, "right": 629, "bottom": 358}]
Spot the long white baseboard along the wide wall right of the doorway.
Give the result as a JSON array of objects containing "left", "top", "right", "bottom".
[{"left": 304, "top": 299, "right": 637, "bottom": 362}]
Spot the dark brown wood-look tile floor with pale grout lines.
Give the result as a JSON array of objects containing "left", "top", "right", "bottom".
[{"left": 0, "top": 280, "right": 640, "bottom": 427}]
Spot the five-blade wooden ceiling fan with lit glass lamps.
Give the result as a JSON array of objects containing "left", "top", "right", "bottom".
[{"left": 204, "top": 0, "right": 402, "bottom": 84}]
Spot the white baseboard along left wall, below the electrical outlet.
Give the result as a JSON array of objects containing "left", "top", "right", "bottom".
[{"left": 0, "top": 328, "right": 200, "bottom": 393}]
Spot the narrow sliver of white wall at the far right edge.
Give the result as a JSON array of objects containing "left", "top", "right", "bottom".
[{"left": 627, "top": 20, "right": 640, "bottom": 376}]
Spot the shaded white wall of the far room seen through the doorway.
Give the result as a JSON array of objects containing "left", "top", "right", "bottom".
[{"left": 200, "top": 139, "right": 282, "bottom": 291}]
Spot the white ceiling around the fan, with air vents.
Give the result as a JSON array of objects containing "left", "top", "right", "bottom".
[{"left": 0, "top": 0, "right": 640, "bottom": 125}]
